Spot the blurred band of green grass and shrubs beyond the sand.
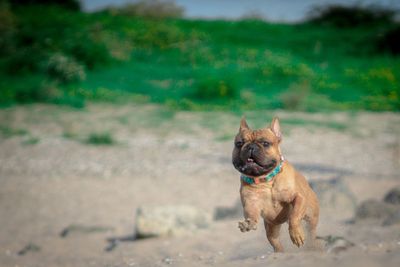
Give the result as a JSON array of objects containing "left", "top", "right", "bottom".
[{"left": 0, "top": 2, "right": 400, "bottom": 111}]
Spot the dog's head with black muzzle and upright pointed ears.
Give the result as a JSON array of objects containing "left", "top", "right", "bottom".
[{"left": 232, "top": 118, "right": 282, "bottom": 177}]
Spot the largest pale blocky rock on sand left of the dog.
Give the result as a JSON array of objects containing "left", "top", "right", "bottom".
[{"left": 135, "top": 205, "right": 211, "bottom": 238}]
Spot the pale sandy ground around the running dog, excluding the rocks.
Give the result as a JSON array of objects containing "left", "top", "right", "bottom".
[{"left": 0, "top": 104, "right": 400, "bottom": 266}]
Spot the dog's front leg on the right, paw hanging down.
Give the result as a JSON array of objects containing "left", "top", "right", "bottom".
[{"left": 289, "top": 193, "right": 306, "bottom": 247}]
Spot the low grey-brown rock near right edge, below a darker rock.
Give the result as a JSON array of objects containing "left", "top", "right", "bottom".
[{"left": 355, "top": 199, "right": 396, "bottom": 220}]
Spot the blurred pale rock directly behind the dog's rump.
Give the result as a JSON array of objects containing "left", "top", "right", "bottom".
[{"left": 310, "top": 178, "right": 357, "bottom": 219}]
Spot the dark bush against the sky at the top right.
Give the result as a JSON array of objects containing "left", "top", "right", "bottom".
[{"left": 308, "top": 5, "right": 396, "bottom": 28}]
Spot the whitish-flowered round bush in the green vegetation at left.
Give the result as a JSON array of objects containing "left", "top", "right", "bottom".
[{"left": 46, "top": 53, "right": 86, "bottom": 84}]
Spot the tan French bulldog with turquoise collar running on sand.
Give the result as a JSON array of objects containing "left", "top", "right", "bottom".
[{"left": 232, "top": 117, "right": 319, "bottom": 252}]
